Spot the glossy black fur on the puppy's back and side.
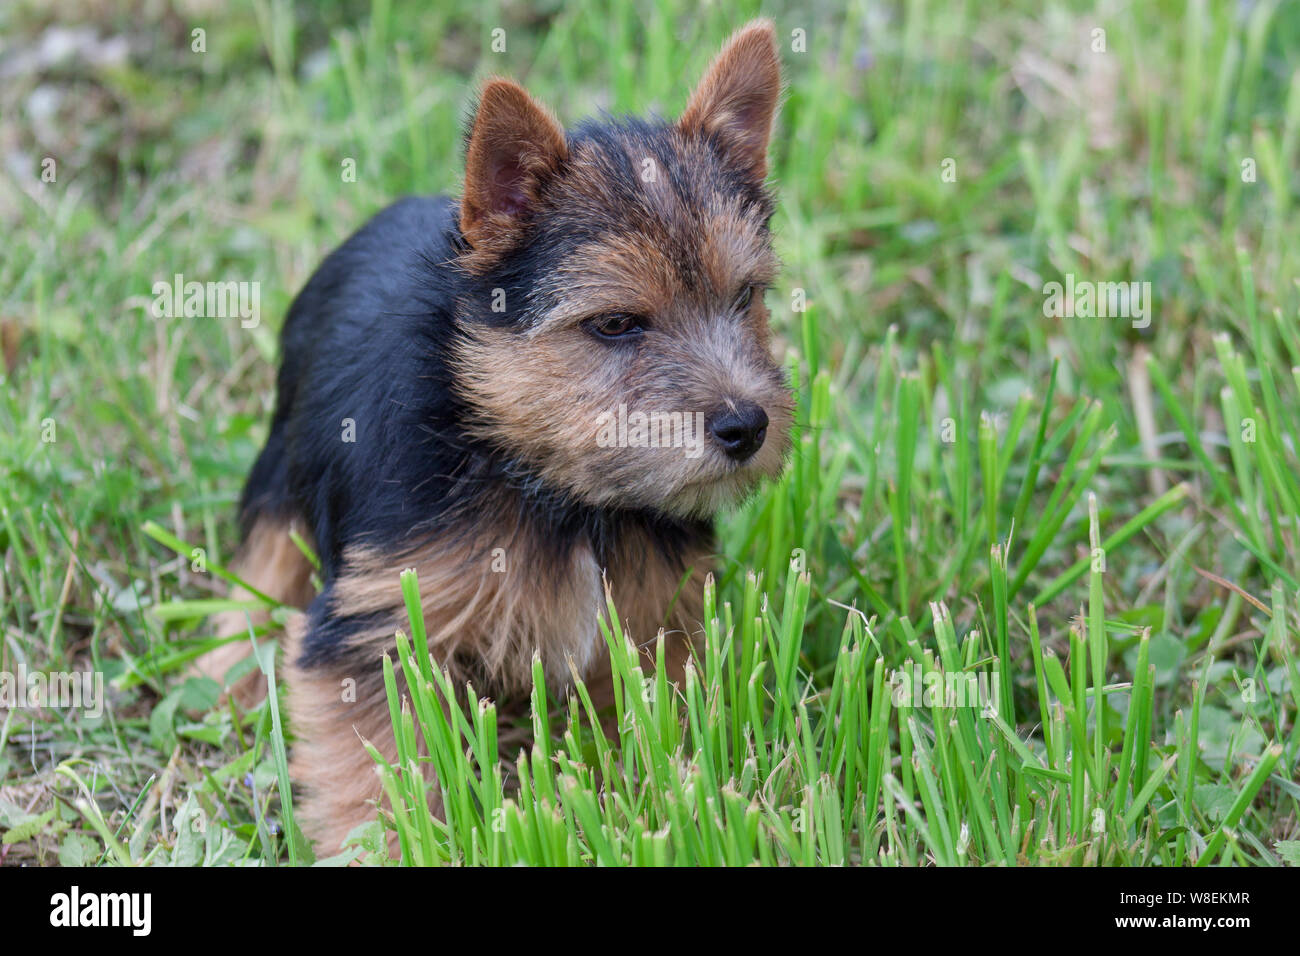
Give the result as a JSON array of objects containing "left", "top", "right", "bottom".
[{"left": 242, "top": 198, "right": 462, "bottom": 567}]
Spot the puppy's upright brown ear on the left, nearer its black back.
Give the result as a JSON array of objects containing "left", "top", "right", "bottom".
[{"left": 460, "top": 79, "right": 568, "bottom": 248}]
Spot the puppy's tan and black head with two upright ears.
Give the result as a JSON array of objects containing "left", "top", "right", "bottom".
[{"left": 454, "top": 21, "right": 793, "bottom": 515}]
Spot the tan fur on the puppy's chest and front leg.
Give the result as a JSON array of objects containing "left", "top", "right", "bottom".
[{"left": 287, "top": 509, "right": 711, "bottom": 851}]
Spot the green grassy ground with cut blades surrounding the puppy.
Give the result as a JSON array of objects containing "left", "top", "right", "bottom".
[{"left": 0, "top": 0, "right": 1300, "bottom": 866}]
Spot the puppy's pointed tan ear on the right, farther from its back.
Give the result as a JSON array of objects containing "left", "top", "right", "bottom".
[{"left": 677, "top": 20, "right": 781, "bottom": 179}]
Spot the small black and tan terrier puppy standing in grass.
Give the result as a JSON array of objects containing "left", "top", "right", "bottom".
[{"left": 203, "top": 21, "right": 792, "bottom": 851}]
